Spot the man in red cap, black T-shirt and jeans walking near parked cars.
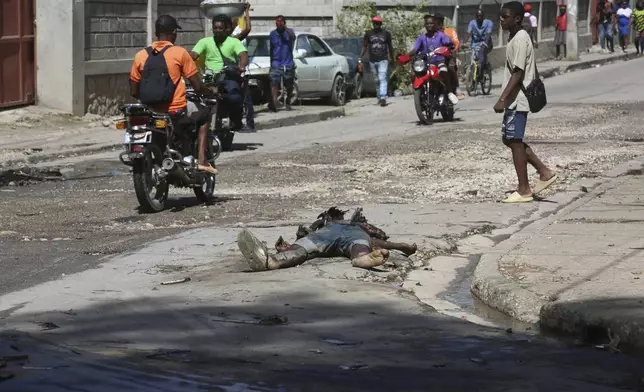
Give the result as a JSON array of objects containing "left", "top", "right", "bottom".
[{"left": 358, "top": 16, "right": 394, "bottom": 107}]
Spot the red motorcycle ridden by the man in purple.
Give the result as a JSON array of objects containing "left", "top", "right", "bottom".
[{"left": 398, "top": 47, "right": 454, "bottom": 125}]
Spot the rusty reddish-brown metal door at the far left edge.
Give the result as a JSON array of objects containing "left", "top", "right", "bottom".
[{"left": 0, "top": 0, "right": 35, "bottom": 108}]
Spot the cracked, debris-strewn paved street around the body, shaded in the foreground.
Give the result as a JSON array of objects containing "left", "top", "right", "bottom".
[{"left": 0, "top": 60, "right": 644, "bottom": 391}]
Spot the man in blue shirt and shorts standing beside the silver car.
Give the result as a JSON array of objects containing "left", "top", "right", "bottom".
[{"left": 269, "top": 15, "right": 295, "bottom": 112}]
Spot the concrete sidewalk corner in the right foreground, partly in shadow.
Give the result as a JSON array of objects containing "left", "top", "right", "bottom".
[{"left": 472, "top": 158, "right": 644, "bottom": 350}]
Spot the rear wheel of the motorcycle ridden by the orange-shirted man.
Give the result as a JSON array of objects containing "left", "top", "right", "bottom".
[{"left": 133, "top": 146, "right": 170, "bottom": 213}]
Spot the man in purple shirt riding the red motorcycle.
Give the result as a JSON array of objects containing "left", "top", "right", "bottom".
[{"left": 409, "top": 15, "right": 458, "bottom": 105}]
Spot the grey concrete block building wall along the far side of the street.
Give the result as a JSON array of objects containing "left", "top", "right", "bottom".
[{"left": 28, "top": 0, "right": 593, "bottom": 115}]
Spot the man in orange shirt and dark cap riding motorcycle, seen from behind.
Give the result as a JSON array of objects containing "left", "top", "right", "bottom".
[{"left": 130, "top": 15, "right": 217, "bottom": 174}]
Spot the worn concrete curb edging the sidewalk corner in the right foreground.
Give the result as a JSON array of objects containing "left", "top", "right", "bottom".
[{"left": 470, "top": 156, "right": 644, "bottom": 324}]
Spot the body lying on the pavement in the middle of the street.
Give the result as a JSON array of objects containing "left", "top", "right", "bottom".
[{"left": 237, "top": 207, "right": 417, "bottom": 271}]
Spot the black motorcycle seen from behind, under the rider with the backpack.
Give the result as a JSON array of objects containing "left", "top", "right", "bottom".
[{"left": 116, "top": 92, "right": 221, "bottom": 212}]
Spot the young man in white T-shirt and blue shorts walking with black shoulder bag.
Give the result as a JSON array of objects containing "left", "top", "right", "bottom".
[{"left": 494, "top": 1, "right": 557, "bottom": 203}]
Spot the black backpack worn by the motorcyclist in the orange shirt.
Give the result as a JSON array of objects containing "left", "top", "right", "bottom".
[{"left": 139, "top": 46, "right": 177, "bottom": 105}]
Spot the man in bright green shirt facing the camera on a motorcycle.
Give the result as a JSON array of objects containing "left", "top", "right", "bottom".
[{"left": 190, "top": 15, "right": 248, "bottom": 130}]
